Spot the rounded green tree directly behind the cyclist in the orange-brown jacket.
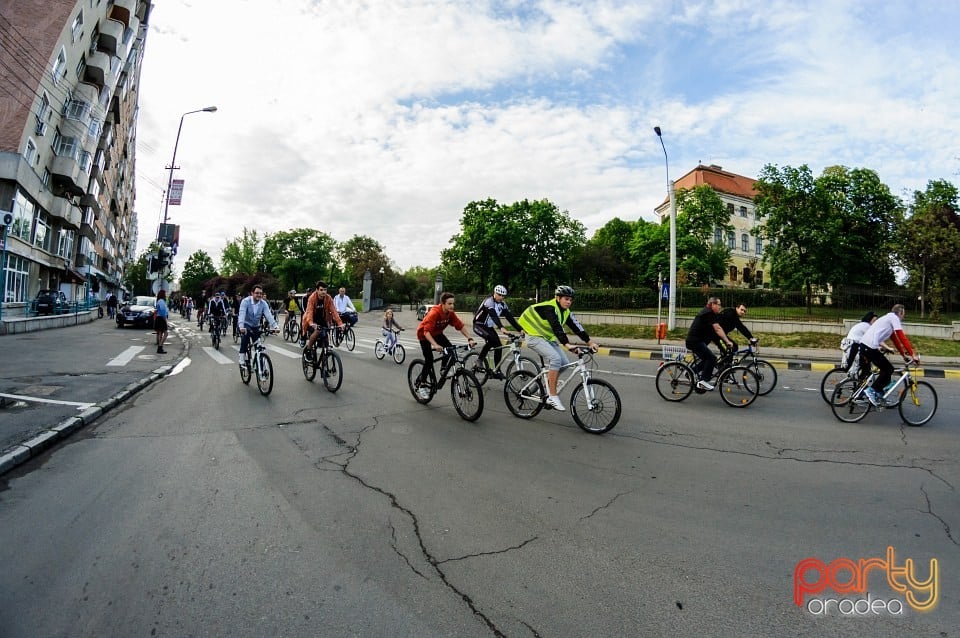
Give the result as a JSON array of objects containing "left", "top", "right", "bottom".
[{"left": 263, "top": 228, "right": 337, "bottom": 290}]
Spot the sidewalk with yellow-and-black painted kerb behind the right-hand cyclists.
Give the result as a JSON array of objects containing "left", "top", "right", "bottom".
[{"left": 595, "top": 337, "right": 960, "bottom": 379}]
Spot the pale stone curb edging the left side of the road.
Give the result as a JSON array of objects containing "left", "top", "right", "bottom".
[{"left": 0, "top": 331, "right": 190, "bottom": 476}]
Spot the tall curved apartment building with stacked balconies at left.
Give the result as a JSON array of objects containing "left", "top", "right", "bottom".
[{"left": 0, "top": 0, "right": 152, "bottom": 316}]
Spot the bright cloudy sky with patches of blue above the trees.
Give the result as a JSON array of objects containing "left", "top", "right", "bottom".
[{"left": 136, "top": 0, "right": 960, "bottom": 272}]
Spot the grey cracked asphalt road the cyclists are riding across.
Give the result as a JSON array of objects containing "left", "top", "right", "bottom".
[{"left": 0, "top": 313, "right": 960, "bottom": 638}]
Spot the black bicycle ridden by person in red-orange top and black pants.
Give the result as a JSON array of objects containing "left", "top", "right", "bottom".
[{"left": 407, "top": 346, "right": 483, "bottom": 421}]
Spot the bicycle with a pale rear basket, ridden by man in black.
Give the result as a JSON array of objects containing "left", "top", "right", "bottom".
[{"left": 656, "top": 346, "right": 760, "bottom": 408}]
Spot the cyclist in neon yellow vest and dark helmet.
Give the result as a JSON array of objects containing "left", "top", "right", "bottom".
[{"left": 519, "top": 286, "right": 599, "bottom": 411}]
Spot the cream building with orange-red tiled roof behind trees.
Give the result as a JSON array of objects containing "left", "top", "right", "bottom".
[{"left": 655, "top": 164, "right": 764, "bottom": 288}]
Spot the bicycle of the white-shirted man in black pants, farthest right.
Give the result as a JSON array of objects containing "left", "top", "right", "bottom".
[{"left": 830, "top": 359, "right": 937, "bottom": 427}]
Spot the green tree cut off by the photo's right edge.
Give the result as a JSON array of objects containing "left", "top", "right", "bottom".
[{"left": 897, "top": 180, "right": 960, "bottom": 321}]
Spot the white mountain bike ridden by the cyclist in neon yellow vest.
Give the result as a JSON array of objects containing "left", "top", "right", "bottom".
[{"left": 503, "top": 346, "right": 622, "bottom": 434}]
